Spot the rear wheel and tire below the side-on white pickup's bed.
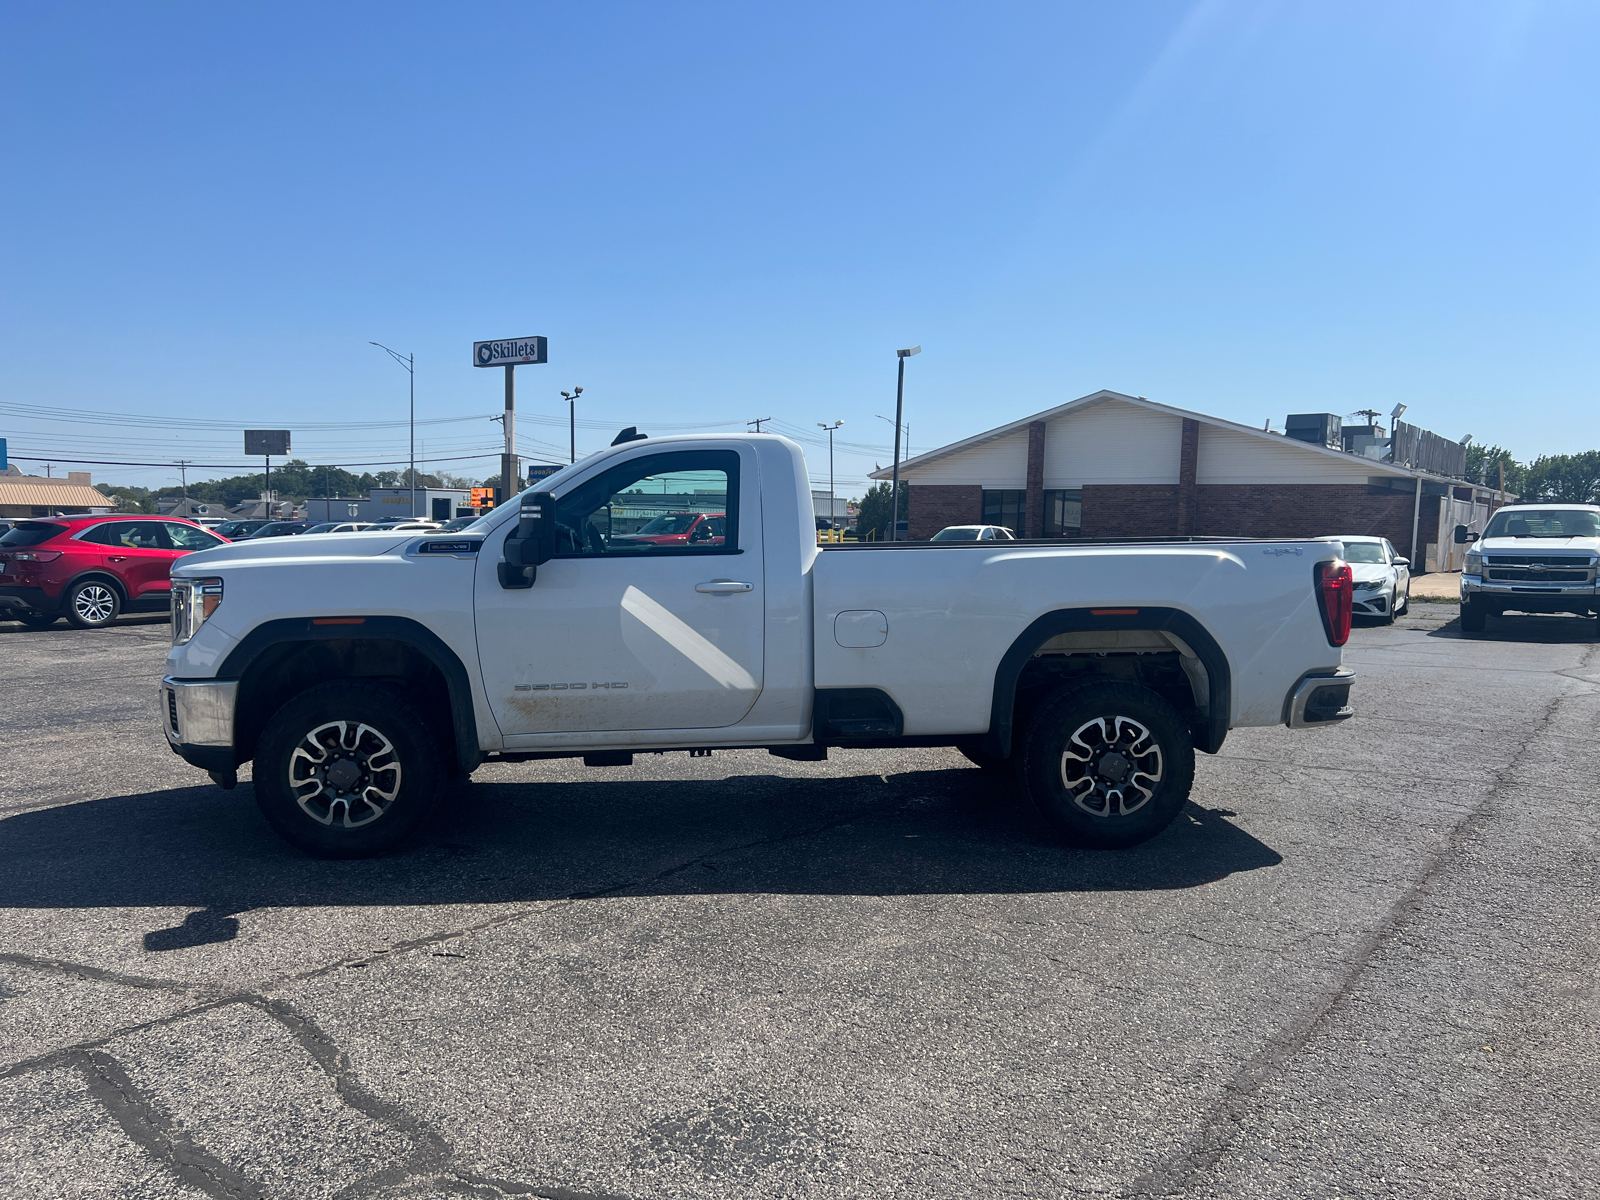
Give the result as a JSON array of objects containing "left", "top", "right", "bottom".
[{"left": 1022, "top": 683, "right": 1195, "bottom": 850}]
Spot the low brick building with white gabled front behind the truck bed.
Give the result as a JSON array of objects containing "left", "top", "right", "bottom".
[{"left": 872, "top": 392, "right": 1494, "bottom": 571}]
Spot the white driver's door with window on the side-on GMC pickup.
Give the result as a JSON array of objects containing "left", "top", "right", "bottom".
[{"left": 475, "top": 448, "right": 766, "bottom": 736}]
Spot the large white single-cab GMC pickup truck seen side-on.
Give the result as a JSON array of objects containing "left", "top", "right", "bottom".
[{"left": 160, "top": 430, "right": 1352, "bottom": 856}]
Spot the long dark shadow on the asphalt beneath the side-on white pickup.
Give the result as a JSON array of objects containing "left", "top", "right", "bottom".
[{"left": 0, "top": 770, "right": 1283, "bottom": 950}]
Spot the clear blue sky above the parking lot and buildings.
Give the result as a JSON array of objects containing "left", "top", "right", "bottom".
[{"left": 0, "top": 0, "right": 1600, "bottom": 491}]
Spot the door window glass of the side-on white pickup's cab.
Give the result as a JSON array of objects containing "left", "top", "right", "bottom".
[{"left": 555, "top": 450, "right": 739, "bottom": 558}]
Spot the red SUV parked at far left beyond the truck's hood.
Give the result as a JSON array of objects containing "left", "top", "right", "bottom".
[{"left": 0, "top": 517, "right": 227, "bottom": 629}]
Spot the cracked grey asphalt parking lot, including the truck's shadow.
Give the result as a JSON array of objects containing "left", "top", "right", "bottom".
[{"left": 0, "top": 605, "right": 1600, "bottom": 1200}]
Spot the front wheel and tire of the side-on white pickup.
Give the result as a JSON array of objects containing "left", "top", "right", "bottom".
[{"left": 254, "top": 682, "right": 445, "bottom": 858}]
